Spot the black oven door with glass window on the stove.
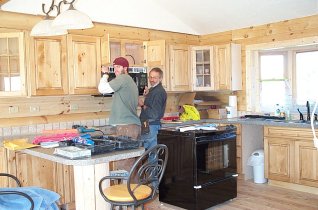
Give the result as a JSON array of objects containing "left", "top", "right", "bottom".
[{"left": 195, "top": 133, "right": 237, "bottom": 185}]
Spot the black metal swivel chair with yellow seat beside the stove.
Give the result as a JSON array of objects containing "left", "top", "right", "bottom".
[{"left": 99, "top": 144, "right": 168, "bottom": 209}]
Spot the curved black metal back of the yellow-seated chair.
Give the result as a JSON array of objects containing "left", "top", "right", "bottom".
[{"left": 127, "top": 144, "right": 168, "bottom": 205}]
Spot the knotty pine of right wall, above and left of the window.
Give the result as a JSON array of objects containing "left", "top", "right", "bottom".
[{"left": 199, "top": 15, "right": 318, "bottom": 111}]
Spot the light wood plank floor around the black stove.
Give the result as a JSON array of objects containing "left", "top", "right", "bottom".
[{"left": 146, "top": 179, "right": 318, "bottom": 210}]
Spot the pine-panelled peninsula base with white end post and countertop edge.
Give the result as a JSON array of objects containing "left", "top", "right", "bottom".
[{"left": 2, "top": 144, "right": 144, "bottom": 210}]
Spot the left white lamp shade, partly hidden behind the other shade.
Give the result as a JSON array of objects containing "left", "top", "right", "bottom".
[{"left": 31, "top": 19, "right": 67, "bottom": 36}]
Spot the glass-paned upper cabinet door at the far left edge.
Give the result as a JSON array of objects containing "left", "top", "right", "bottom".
[{"left": 0, "top": 32, "right": 27, "bottom": 96}]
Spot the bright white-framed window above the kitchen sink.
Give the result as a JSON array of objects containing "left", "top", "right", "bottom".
[{"left": 246, "top": 43, "right": 318, "bottom": 114}]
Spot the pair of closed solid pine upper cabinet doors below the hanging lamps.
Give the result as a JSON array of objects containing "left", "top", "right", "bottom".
[{"left": 30, "top": 34, "right": 101, "bottom": 95}]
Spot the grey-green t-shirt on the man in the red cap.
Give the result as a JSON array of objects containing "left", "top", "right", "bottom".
[{"left": 109, "top": 74, "right": 140, "bottom": 125}]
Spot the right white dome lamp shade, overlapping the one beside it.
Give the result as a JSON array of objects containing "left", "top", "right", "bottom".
[{"left": 52, "top": 9, "right": 94, "bottom": 29}]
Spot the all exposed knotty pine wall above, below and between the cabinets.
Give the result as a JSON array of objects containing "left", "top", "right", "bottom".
[{"left": 0, "top": 11, "right": 318, "bottom": 128}]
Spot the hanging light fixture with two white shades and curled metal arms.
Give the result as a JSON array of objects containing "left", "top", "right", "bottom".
[{"left": 31, "top": 0, "right": 94, "bottom": 36}]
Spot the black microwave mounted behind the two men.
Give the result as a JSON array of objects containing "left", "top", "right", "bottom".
[{"left": 108, "top": 66, "right": 148, "bottom": 95}]
